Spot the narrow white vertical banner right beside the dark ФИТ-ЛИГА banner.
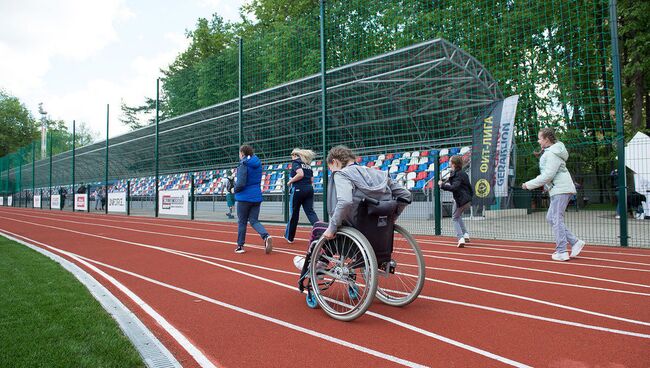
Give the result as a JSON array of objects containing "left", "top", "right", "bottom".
[{"left": 494, "top": 95, "right": 519, "bottom": 197}]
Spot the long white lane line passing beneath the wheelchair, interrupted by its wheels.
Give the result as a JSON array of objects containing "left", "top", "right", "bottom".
[{"left": 1, "top": 217, "right": 528, "bottom": 367}]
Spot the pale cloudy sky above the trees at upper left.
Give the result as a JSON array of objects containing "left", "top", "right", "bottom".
[{"left": 0, "top": 0, "right": 245, "bottom": 140}]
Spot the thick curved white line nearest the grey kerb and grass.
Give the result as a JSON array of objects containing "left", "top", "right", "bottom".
[{"left": 2, "top": 229, "right": 216, "bottom": 368}]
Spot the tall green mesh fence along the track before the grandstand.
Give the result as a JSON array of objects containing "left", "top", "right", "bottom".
[{"left": 0, "top": 0, "right": 650, "bottom": 246}]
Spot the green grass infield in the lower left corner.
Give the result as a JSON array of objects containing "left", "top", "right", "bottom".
[{"left": 0, "top": 237, "right": 144, "bottom": 368}]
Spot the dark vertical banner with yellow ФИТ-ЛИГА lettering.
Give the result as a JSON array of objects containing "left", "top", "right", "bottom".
[{"left": 472, "top": 100, "right": 503, "bottom": 206}]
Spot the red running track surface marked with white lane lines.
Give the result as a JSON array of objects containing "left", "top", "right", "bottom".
[{"left": 0, "top": 207, "right": 650, "bottom": 367}]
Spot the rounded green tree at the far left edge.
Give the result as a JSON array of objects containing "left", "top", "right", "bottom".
[{"left": 0, "top": 90, "right": 38, "bottom": 157}]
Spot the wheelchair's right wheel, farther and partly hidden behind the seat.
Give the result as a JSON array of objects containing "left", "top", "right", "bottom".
[{"left": 377, "top": 225, "right": 425, "bottom": 307}]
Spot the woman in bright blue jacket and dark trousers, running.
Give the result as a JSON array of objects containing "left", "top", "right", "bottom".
[{"left": 235, "top": 145, "right": 273, "bottom": 254}]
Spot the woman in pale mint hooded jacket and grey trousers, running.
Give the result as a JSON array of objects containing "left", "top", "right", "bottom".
[{"left": 521, "top": 128, "right": 585, "bottom": 261}]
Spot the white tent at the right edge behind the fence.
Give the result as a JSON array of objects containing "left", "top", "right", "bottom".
[{"left": 625, "top": 132, "right": 650, "bottom": 216}]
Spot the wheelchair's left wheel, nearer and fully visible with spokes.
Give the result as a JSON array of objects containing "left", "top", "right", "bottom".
[{"left": 309, "top": 226, "right": 377, "bottom": 321}]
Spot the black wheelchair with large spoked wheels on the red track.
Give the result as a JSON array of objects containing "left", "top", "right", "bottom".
[{"left": 298, "top": 198, "right": 425, "bottom": 321}]
